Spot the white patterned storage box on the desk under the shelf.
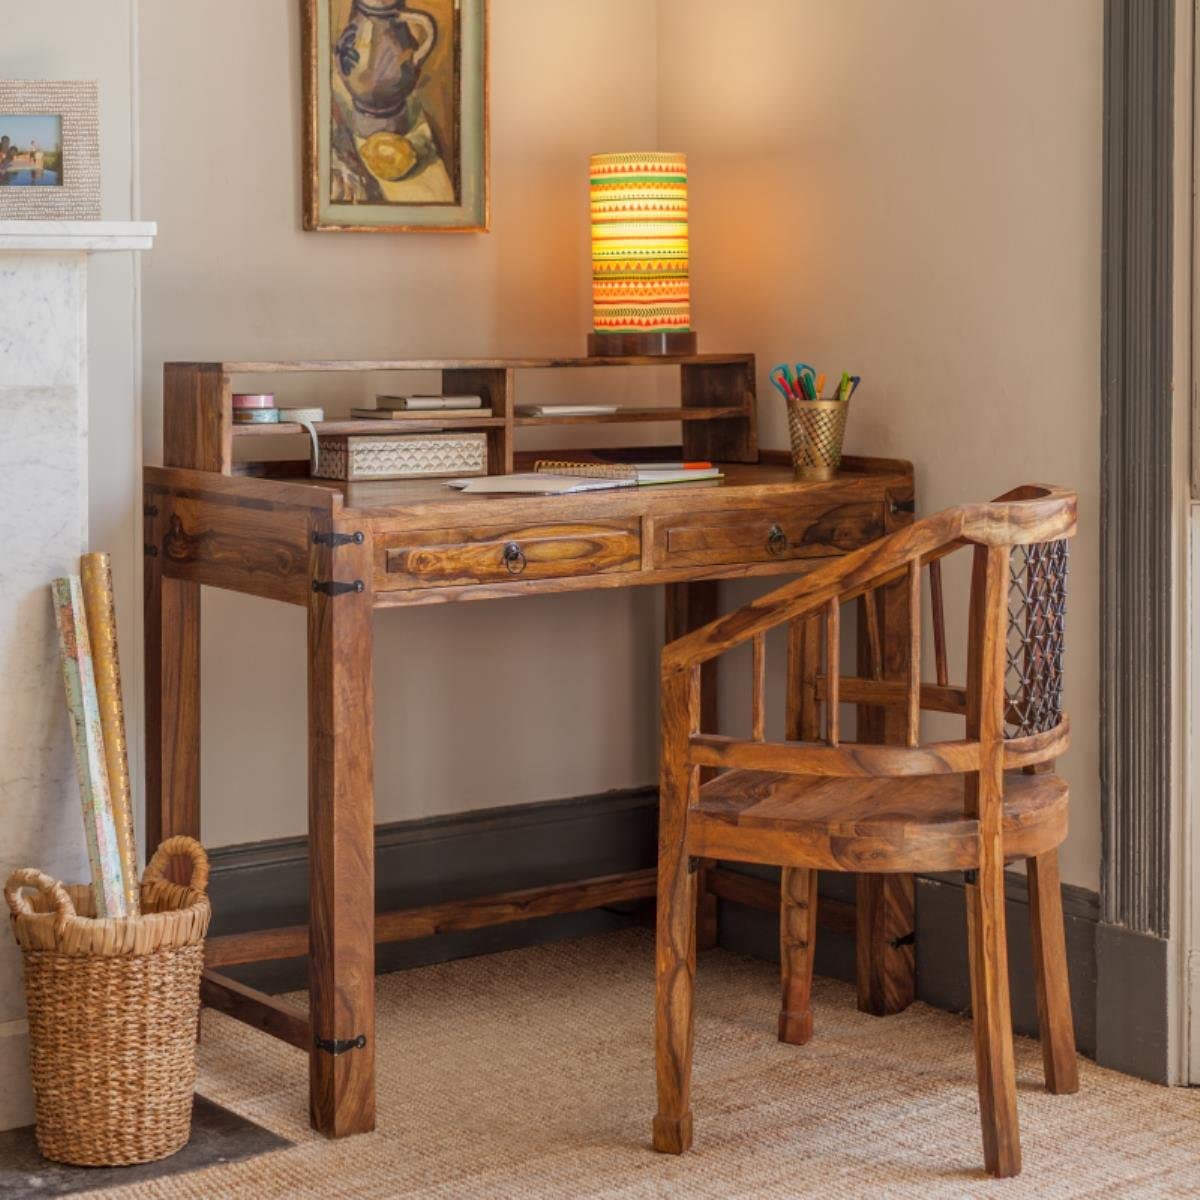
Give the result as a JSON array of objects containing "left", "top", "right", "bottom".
[{"left": 313, "top": 433, "right": 487, "bottom": 482}]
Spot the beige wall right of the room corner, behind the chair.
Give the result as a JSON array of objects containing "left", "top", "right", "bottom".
[{"left": 659, "top": 0, "right": 1103, "bottom": 888}]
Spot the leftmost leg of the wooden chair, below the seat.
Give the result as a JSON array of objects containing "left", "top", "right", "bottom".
[{"left": 654, "top": 839, "right": 697, "bottom": 1154}]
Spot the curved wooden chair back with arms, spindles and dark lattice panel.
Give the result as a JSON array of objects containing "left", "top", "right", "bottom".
[{"left": 664, "top": 485, "right": 1076, "bottom": 792}]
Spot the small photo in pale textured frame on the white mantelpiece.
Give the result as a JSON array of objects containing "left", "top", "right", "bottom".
[{"left": 0, "top": 79, "right": 100, "bottom": 221}]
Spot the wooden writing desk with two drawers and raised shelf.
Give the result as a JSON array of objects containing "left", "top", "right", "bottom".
[{"left": 144, "top": 355, "right": 913, "bottom": 1136}]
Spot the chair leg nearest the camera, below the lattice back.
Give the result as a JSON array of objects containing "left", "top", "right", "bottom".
[{"left": 966, "top": 856, "right": 1021, "bottom": 1177}]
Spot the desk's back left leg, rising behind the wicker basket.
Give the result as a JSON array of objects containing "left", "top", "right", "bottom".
[{"left": 144, "top": 505, "right": 200, "bottom": 859}]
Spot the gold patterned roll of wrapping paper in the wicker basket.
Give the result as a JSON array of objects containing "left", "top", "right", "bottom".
[{"left": 79, "top": 554, "right": 142, "bottom": 917}]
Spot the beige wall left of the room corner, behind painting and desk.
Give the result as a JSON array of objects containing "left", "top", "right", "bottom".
[{"left": 140, "top": 0, "right": 659, "bottom": 844}]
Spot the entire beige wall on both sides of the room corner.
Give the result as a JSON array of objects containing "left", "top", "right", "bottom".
[{"left": 140, "top": 0, "right": 1102, "bottom": 887}]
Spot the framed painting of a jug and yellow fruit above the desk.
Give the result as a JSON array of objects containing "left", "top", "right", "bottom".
[{"left": 300, "top": 0, "right": 491, "bottom": 233}]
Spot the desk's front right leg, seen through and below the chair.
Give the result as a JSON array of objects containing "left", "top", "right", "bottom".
[{"left": 856, "top": 583, "right": 917, "bottom": 1016}]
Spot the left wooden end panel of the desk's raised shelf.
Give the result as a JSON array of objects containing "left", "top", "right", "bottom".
[{"left": 162, "top": 362, "right": 233, "bottom": 475}]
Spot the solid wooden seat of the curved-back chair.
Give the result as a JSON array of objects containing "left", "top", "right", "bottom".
[{"left": 688, "top": 770, "right": 1068, "bottom": 872}]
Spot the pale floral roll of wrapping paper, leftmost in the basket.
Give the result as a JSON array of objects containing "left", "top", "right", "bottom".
[{"left": 50, "top": 575, "right": 128, "bottom": 917}]
